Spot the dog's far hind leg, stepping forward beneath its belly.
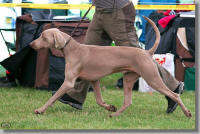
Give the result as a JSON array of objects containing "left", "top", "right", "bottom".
[{"left": 110, "top": 72, "right": 139, "bottom": 117}]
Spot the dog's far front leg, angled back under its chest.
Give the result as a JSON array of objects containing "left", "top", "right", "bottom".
[{"left": 91, "top": 80, "right": 117, "bottom": 112}]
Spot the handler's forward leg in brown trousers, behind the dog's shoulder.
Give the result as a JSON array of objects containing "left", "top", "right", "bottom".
[{"left": 53, "top": 13, "right": 112, "bottom": 109}]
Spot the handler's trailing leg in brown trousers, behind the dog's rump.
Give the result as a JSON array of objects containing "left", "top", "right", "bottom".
[{"left": 104, "top": 1, "right": 183, "bottom": 113}]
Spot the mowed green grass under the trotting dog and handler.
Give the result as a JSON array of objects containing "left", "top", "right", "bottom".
[{"left": 0, "top": 74, "right": 195, "bottom": 130}]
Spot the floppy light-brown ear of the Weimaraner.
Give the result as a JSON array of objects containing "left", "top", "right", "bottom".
[{"left": 53, "top": 30, "right": 67, "bottom": 49}]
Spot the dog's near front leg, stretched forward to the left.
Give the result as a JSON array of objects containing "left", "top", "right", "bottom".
[{"left": 35, "top": 65, "right": 78, "bottom": 114}]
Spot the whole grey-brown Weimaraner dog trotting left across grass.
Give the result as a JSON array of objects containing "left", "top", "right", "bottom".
[{"left": 30, "top": 16, "right": 192, "bottom": 117}]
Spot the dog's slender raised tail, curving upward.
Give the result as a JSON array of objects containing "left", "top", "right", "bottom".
[{"left": 143, "top": 16, "right": 160, "bottom": 55}]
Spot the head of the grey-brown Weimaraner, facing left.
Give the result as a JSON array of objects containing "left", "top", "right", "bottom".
[{"left": 30, "top": 28, "right": 71, "bottom": 50}]
